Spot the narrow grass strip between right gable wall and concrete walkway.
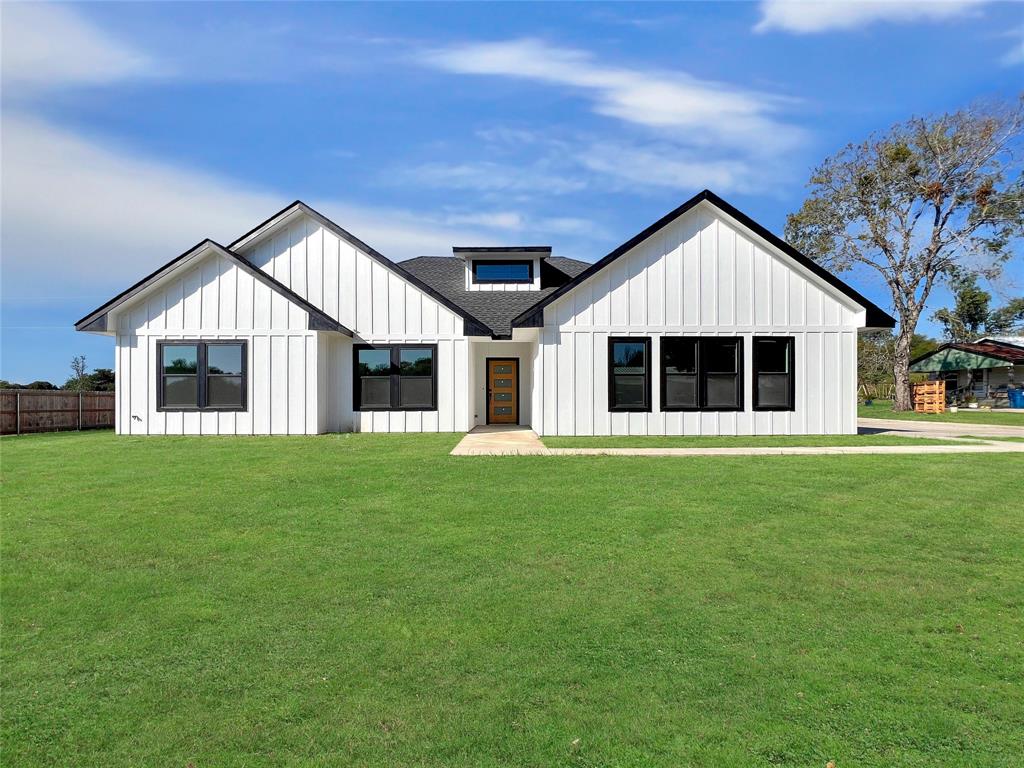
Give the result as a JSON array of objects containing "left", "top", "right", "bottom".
[{"left": 542, "top": 434, "right": 963, "bottom": 447}]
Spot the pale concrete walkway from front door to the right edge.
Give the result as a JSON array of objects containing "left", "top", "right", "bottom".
[{"left": 452, "top": 428, "right": 1024, "bottom": 456}]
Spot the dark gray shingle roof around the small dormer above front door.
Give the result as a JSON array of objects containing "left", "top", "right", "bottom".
[{"left": 400, "top": 256, "right": 590, "bottom": 336}]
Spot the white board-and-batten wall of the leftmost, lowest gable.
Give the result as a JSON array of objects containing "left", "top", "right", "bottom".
[{"left": 113, "top": 254, "right": 321, "bottom": 434}]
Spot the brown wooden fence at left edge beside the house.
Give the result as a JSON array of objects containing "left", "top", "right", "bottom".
[{"left": 0, "top": 389, "right": 114, "bottom": 434}]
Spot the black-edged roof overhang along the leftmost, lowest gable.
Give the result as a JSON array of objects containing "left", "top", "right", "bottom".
[{"left": 75, "top": 239, "right": 352, "bottom": 336}]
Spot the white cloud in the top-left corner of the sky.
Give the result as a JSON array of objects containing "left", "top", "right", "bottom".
[{"left": 0, "top": 2, "right": 156, "bottom": 89}]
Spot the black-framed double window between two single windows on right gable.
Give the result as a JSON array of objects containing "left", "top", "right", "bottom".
[{"left": 660, "top": 336, "right": 743, "bottom": 411}]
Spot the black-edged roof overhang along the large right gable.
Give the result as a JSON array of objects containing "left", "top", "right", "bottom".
[{"left": 512, "top": 189, "right": 896, "bottom": 328}]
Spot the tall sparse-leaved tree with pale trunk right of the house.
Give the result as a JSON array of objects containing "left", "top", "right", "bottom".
[{"left": 785, "top": 99, "right": 1024, "bottom": 411}]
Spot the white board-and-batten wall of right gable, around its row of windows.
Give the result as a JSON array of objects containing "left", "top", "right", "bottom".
[{"left": 532, "top": 205, "right": 863, "bottom": 435}]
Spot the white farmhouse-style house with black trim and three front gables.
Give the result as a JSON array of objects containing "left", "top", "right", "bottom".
[{"left": 76, "top": 190, "right": 894, "bottom": 435}]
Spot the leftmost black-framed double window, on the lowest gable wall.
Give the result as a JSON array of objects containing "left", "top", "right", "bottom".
[{"left": 157, "top": 341, "right": 248, "bottom": 411}]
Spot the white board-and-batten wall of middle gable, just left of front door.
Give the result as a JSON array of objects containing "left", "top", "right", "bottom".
[{"left": 241, "top": 214, "right": 472, "bottom": 432}]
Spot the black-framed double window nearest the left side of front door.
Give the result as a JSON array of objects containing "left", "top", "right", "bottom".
[{"left": 352, "top": 344, "right": 437, "bottom": 411}]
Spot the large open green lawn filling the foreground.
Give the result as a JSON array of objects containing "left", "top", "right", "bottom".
[{"left": 6, "top": 432, "right": 1024, "bottom": 768}]
